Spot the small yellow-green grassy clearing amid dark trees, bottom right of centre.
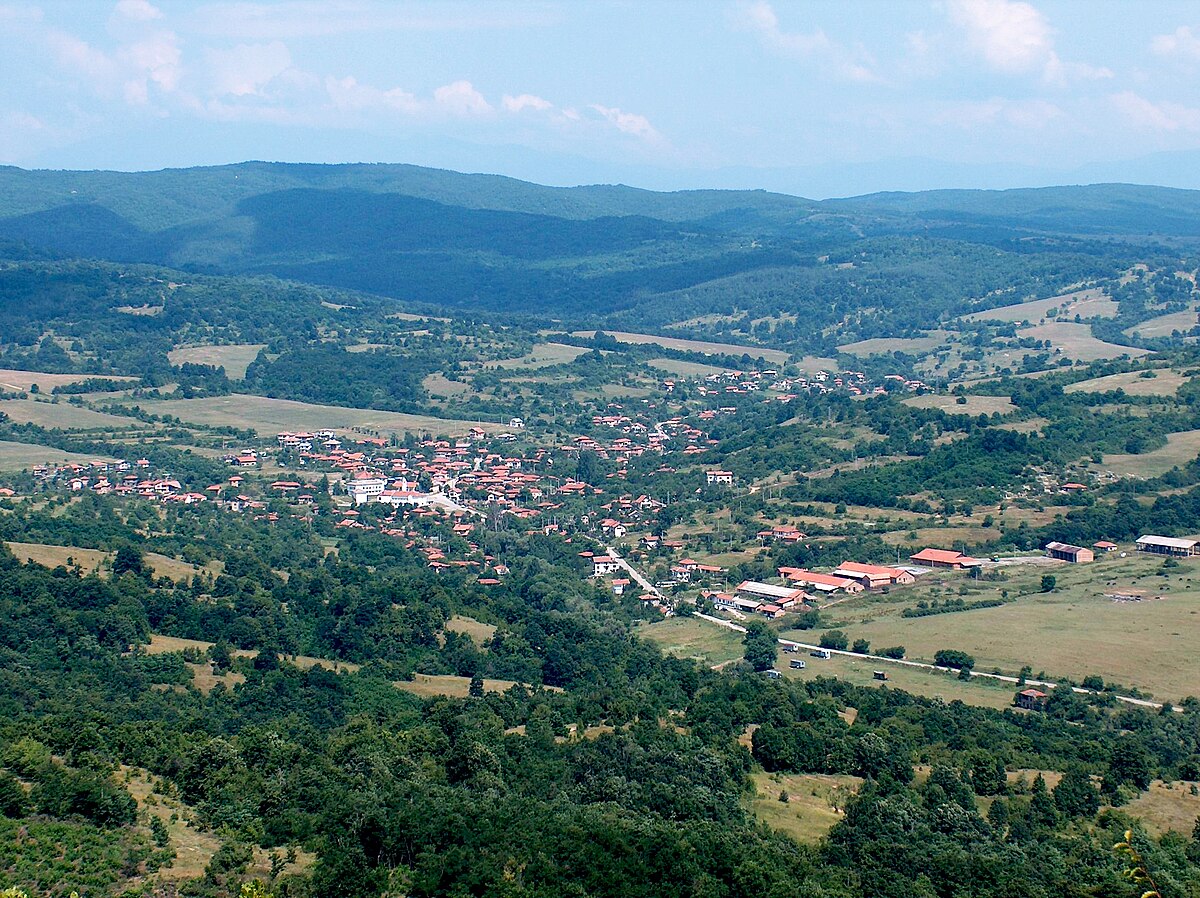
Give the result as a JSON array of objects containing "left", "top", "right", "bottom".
[{"left": 748, "top": 771, "right": 863, "bottom": 843}]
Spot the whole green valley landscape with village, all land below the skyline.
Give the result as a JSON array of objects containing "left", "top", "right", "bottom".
[{"left": 0, "top": 163, "right": 1200, "bottom": 898}]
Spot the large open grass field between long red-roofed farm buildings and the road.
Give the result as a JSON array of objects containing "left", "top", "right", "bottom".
[{"left": 830, "top": 553, "right": 1200, "bottom": 702}]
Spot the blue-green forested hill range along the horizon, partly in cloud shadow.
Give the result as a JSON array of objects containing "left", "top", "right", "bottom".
[{"left": 0, "top": 162, "right": 1200, "bottom": 328}]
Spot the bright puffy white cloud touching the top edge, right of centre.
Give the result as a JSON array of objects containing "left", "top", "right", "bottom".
[{"left": 948, "top": 0, "right": 1112, "bottom": 84}]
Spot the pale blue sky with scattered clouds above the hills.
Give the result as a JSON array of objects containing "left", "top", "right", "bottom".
[{"left": 7, "top": 0, "right": 1200, "bottom": 198}]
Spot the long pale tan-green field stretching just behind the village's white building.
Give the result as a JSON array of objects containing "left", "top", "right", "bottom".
[{"left": 117, "top": 393, "right": 503, "bottom": 436}]
